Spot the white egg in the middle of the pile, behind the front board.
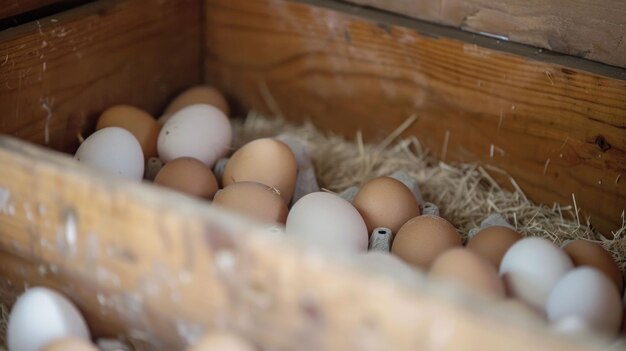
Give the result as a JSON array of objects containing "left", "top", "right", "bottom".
[{"left": 286, "top": 192, "right": 368, "bottom": 252}]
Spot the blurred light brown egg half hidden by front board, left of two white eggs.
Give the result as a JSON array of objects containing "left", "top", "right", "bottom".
[{"left": 428, "top": 247, "right": 505, "bottom": 298}]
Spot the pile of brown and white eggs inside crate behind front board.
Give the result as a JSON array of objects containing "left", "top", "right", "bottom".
[{"left": 7, "top": 87, "right": 626, "bottom": 350}]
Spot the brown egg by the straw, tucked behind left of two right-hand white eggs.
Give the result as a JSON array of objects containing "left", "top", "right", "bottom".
[{"left": 467, "top": 226, "right": 522, "bottom": 268}]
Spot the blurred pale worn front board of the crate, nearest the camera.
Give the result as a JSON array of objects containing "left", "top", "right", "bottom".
[{"left": 0, "top": 137, "right": 600, "bottom": 351}]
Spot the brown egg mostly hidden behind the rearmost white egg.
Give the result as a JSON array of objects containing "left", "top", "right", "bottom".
[{"left": 159, "top": 85, "right": 230, "bottom": 123}]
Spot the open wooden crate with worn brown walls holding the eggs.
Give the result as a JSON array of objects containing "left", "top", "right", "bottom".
[{"left": 0, "top": 0, "right": 626, "bottom": 350}]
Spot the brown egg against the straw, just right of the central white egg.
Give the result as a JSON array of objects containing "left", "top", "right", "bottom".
[{"left": 352, "top": 177, "right": 420, "bottom": 236}]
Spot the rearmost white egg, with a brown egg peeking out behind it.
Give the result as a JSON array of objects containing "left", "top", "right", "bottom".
[{"left": 157, "top": 104, "right": 232, "bottom": 167}]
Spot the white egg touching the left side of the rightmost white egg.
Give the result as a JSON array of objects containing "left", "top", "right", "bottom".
[{"left": 500, "top": 238, "right": 573, "bottom": 309}]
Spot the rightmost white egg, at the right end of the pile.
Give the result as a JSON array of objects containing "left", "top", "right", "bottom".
[{"left": 546, "top": 266, "right": 622, "bottom": 334}]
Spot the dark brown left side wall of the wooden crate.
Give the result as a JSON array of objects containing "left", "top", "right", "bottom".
[{"left": 0, "top": 0, "right": 202, "bottom": 155}]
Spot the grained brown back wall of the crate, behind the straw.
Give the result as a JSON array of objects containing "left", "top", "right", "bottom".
[{"left": 205, "top": 0, "right": 626, "bottom": 233}]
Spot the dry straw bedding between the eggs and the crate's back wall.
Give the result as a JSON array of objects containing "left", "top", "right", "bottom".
[{"left": 234, "top": 112, "right": 626, "bottom": 271}]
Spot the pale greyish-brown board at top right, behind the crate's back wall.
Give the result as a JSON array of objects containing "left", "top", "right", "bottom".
[{"left": 346, "top": 0, "right": 626, "bottom": 67}]
